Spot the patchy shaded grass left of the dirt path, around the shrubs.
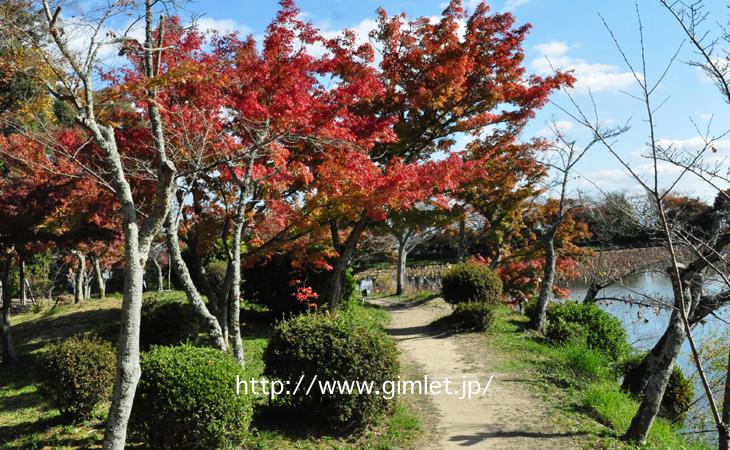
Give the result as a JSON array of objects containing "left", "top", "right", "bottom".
[{"left": 0, "top": 293, "right": 420, "bottom": 450}]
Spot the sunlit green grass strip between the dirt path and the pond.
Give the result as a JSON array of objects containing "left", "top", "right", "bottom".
[{"left": 485, "top": 308, "right": 707, "bottom": 450}]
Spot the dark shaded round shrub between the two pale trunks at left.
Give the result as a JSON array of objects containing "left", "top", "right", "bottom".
[{"left": 140, "top": 293, "right": 202, "bottom": 350}]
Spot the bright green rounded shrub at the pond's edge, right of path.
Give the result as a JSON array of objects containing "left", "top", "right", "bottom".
[{"left": 546, "top": 302, "right": 629, "bottom": 362}]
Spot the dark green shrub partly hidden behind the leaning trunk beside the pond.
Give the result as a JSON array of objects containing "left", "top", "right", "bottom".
[{"left": 621, "top": 354, "right": 694, "bottom": 424}]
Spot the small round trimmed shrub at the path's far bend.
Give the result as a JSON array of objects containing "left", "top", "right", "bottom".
[{"left": 441, "top": 263, "right": 502, "bottom": 304}]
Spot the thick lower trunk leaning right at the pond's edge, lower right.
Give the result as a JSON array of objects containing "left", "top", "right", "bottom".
[{"left": 624, "top": 310, "right": 684, "bottom": 443}]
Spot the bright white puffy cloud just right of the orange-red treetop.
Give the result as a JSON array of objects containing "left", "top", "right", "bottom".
[{"left": 530, "top": 41, "right": 635, "bottom": 93}]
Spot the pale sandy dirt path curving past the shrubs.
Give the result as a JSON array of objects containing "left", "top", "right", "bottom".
[{"left": 372, "top": 299, "right": 579, "bottom": 450}]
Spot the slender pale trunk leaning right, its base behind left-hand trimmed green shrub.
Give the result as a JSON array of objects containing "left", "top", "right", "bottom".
[{"left": 165, "top": 211, "right": 228, "bottom": 352}]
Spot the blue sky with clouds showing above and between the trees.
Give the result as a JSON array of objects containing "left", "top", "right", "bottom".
[{"left": 148, "top": 0, "right": 730, "bottom": 197}]
